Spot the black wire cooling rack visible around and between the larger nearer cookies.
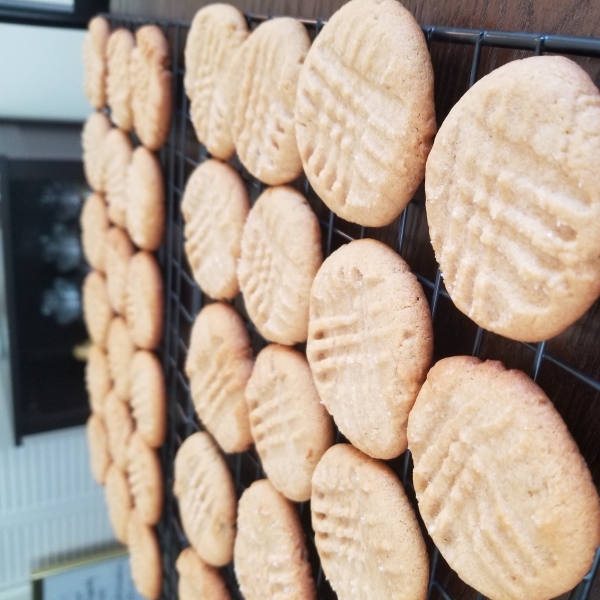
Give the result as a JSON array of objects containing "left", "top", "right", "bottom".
[{"left": 107, "top": 15, "right": 600, "bottom": 600}]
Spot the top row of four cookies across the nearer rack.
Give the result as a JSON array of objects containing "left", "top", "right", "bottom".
[{"left": 184, "top": 0, "right": 600, "bottom": 342}]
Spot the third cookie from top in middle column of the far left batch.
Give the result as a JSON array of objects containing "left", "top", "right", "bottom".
[{"left": 104, "top": 227, "right": 135, "bottom": 314}]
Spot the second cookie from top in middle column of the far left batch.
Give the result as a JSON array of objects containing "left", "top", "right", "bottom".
[{"left": 104, "top": 127, "right": 133, "bottom": 227}]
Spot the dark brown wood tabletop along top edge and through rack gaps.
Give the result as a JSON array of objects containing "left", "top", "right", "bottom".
[{"left": 111, "top": 0, "right": 600, "bottom": 600}]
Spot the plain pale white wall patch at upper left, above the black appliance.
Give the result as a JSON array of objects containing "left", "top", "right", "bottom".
[{"left": 0, "top": 23, "right": 91, "bottom": 121}]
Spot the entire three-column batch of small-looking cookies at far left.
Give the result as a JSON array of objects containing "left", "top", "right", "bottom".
[{"left": 81, "top": 17, "right": 172, "bottom": 598}]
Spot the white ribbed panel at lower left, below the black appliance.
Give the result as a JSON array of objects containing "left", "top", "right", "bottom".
[{"left": 0, "top": 427, "right": 116, "bottom": 599}]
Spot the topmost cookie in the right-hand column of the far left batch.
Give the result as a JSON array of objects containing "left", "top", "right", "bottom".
[{"left": 130, "top": 25, "right": 173, "bottom": 150}]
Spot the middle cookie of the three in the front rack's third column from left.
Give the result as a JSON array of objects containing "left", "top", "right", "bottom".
[{"left": 306, "top": 239, "right": 433, "bottom": 458}]
